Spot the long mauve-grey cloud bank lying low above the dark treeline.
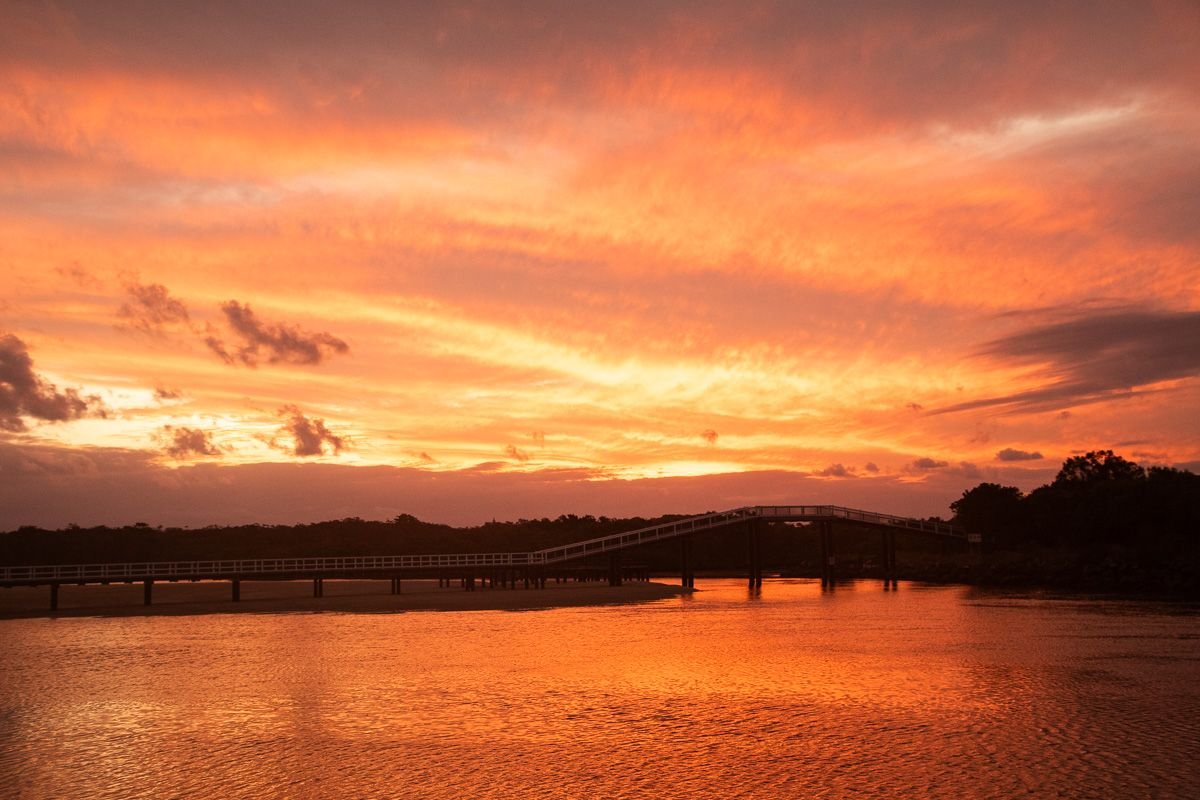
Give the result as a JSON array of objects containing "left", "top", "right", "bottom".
[{"left": 0, "top": 450, "right": 1196, "bottom": 530}]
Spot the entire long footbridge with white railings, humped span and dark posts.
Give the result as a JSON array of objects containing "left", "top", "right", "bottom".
[{"left": 0, "top": 505, "right": 979, "bottom": 610}]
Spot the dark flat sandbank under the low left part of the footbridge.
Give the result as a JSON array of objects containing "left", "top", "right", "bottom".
[{"left": 0, "top": 579, "right": 688, "bottom": 619}]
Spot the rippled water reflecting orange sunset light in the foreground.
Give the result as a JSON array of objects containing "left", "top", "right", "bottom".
[{"left": 0, "top": 581, "right": 1200, "bottom": 799}]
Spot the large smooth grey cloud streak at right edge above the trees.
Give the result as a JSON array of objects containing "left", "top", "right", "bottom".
[{"left": 935, "top": 309, "right": 1200, "bottom": 414}]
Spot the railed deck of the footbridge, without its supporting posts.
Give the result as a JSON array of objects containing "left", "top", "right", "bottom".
[{"left": 0, "top": 505, "right": 968, "bottom": 587}]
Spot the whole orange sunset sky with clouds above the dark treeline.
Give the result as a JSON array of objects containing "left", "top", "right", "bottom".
[{"left": 0, "top": 0, "right": 1200, "bottom": 529}]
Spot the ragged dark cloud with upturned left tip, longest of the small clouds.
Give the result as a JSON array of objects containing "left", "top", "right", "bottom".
[{"left": 204, "top": 300, "right": 350, "bottom": 367}]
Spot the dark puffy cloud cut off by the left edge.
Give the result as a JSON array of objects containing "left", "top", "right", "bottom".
[{"left": 0, "top": 333, "right": 103, "bottom": 432}]
